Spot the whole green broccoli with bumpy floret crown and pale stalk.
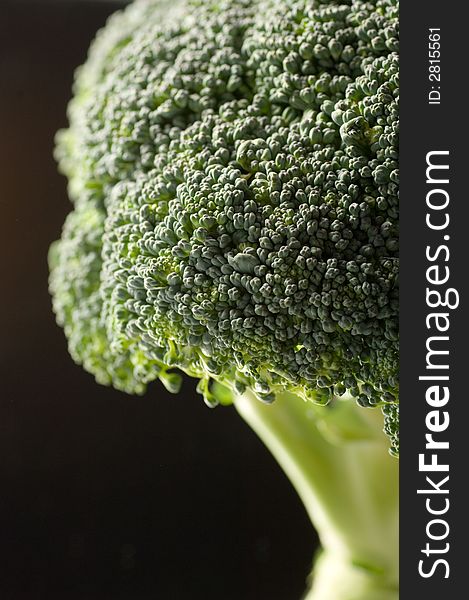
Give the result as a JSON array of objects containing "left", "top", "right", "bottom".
[{"left": 50, "top": 0, "right": 399, "bottom": 600}]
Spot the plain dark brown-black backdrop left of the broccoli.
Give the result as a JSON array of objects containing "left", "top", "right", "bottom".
[{"left": 0, "top": 0, "right": 315, "bottom": 600}]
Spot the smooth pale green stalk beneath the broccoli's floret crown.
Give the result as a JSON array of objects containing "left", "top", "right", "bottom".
[{"left": 235, "top": 393, "right": 399, "bottom": 600}]
